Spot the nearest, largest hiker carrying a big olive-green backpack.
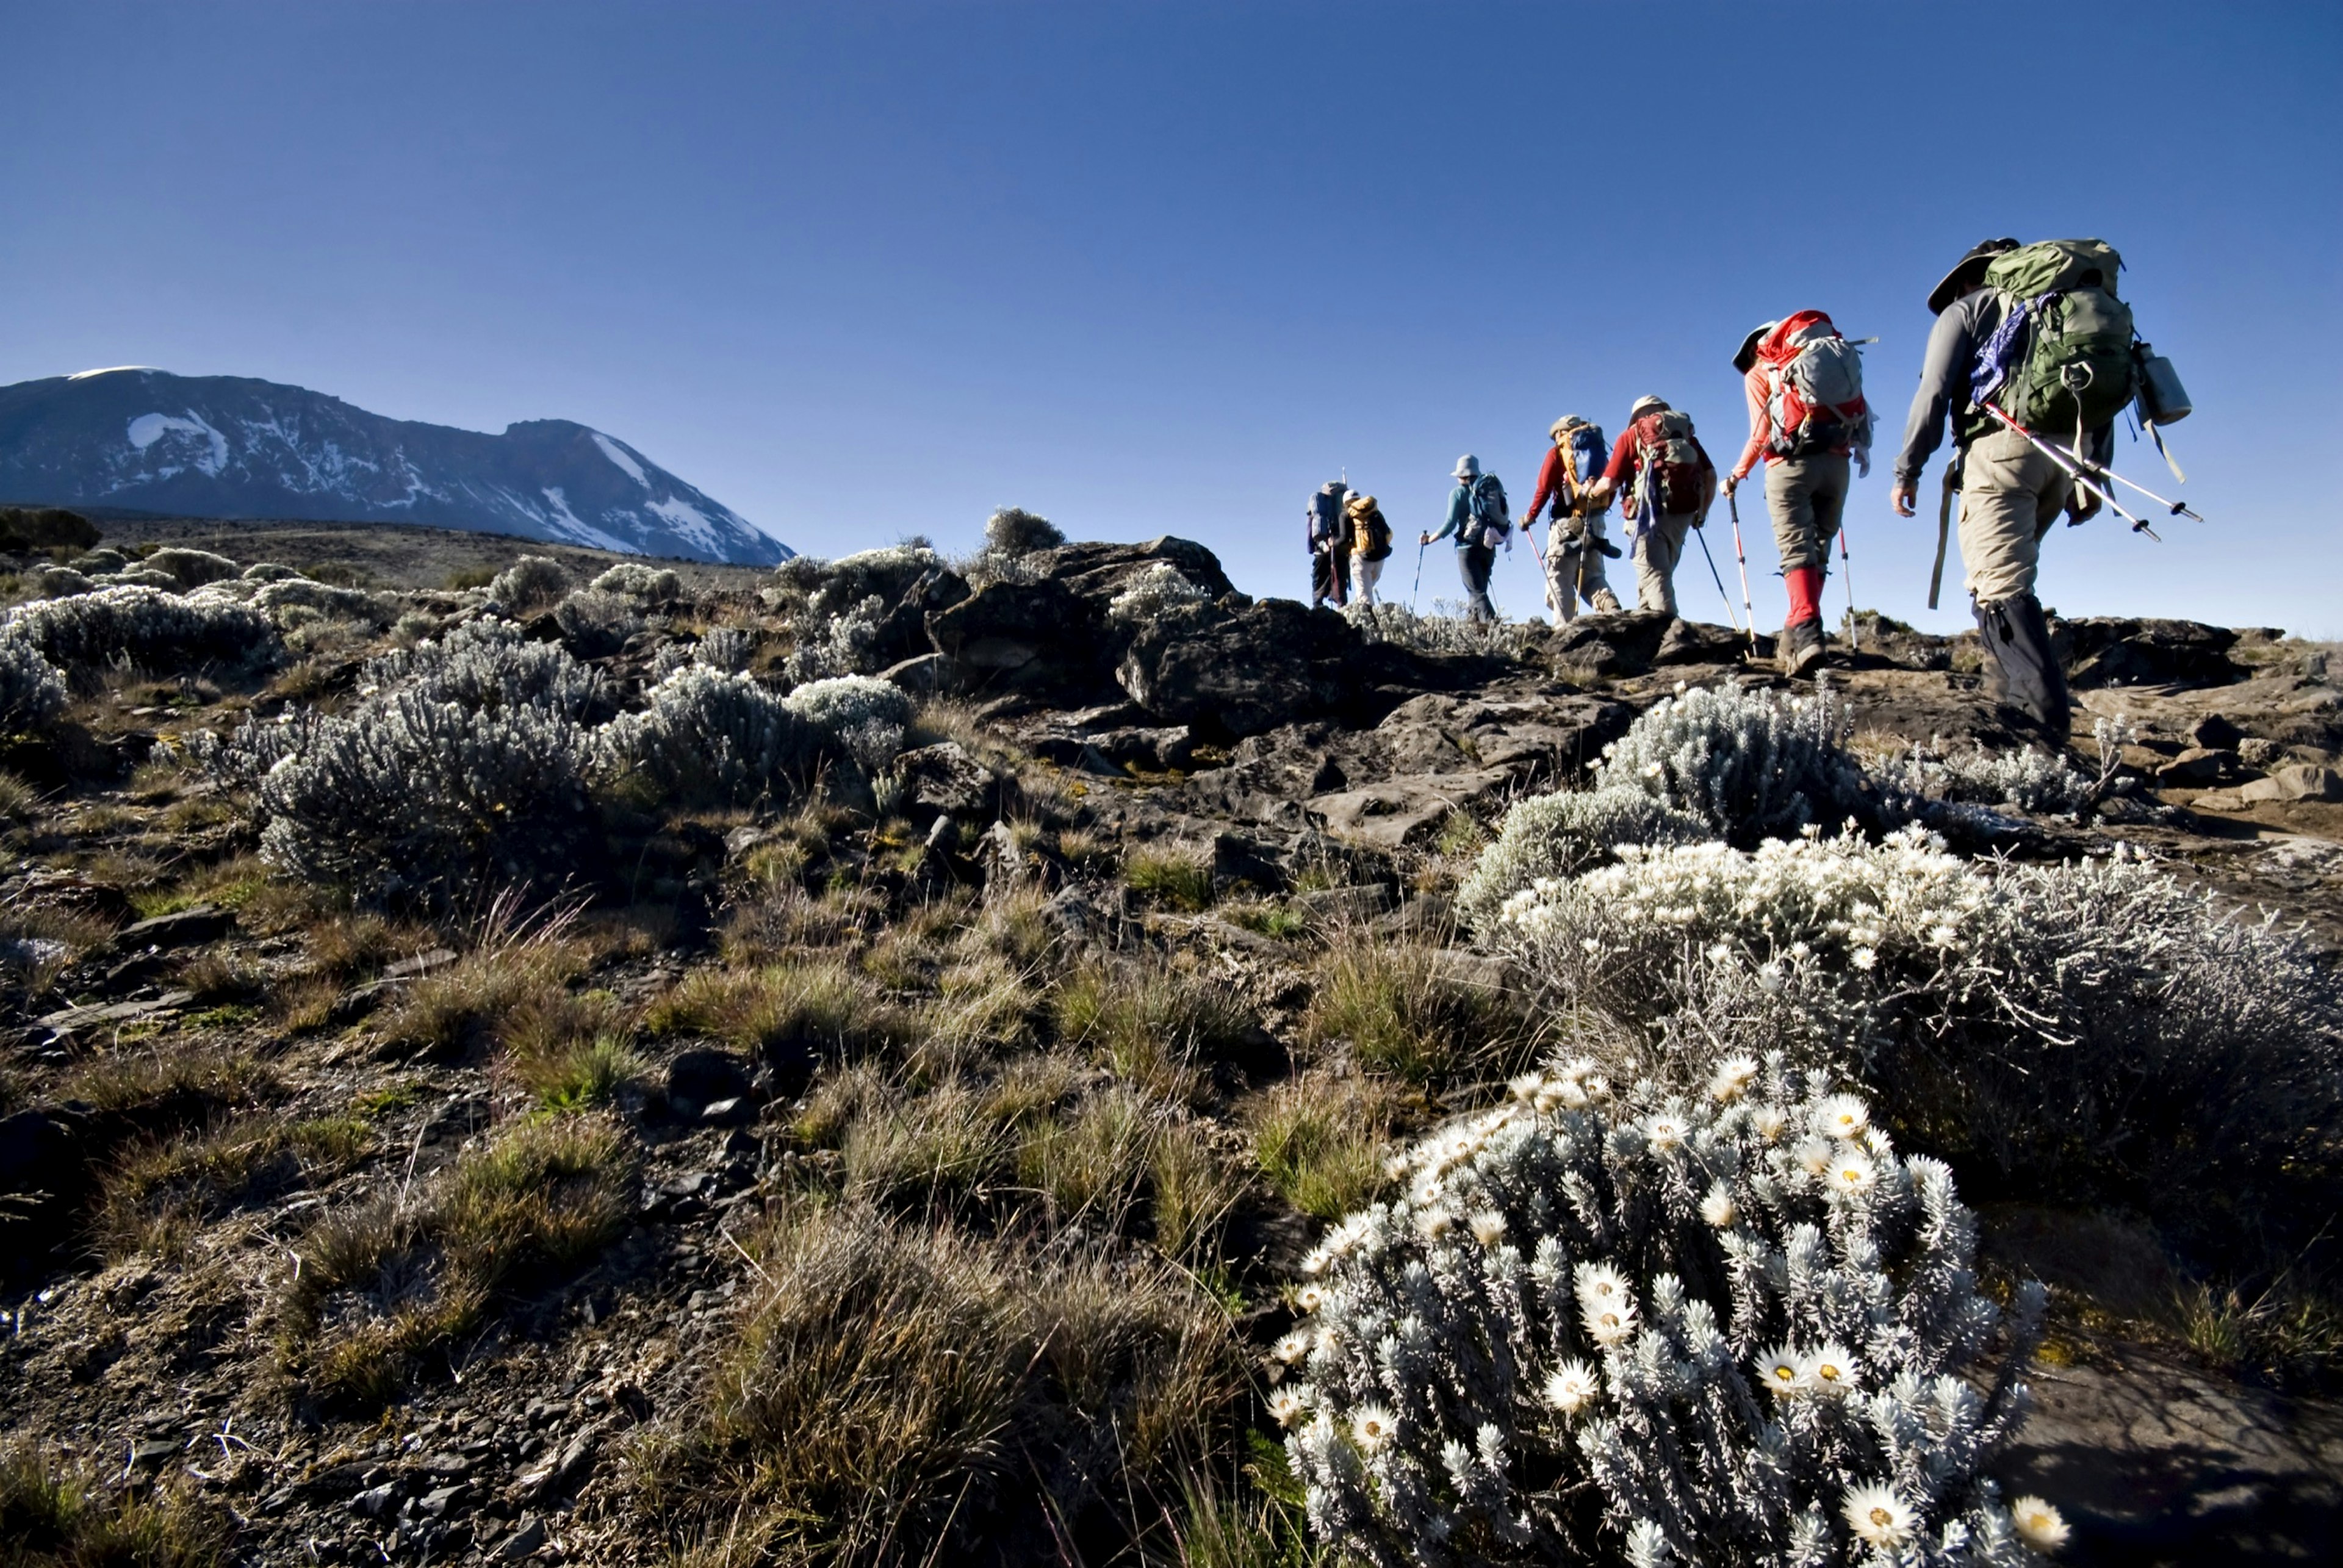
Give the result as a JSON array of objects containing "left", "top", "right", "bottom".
[{"left": 1891, "top": 239, "right": 2134, "bottom": 746}]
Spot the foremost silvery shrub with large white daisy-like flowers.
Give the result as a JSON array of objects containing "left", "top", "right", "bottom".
[{"left": 1272, "top": 1057, "right": 2055, "bottom": 1568}]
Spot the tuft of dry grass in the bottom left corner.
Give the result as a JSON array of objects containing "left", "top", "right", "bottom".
[{"left": 0, "top": 1437, "right": 229, "bottom": 1568}]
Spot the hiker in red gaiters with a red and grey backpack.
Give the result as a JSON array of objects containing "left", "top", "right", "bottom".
[{"left": 1724, "top": 309, "right": 1872, "bottom": 675}]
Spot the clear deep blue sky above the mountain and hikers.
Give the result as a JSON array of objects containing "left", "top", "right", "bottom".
[{"left": 0, "top": 0, "right": 2343, "bottom": 638}]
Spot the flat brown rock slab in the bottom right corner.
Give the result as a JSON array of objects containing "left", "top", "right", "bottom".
[{"left": 1999, "top": 1357, "right": 2343, "bottom": 1568}]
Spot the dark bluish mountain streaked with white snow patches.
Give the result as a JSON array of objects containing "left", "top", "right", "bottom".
[{"left": 0, "top": 365, "right": 794, "bottom": 565}]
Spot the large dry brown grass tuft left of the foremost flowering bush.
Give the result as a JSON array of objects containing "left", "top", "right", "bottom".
[{"left": 635, "top": 1205, "right": 1242, "bottom": 1563}]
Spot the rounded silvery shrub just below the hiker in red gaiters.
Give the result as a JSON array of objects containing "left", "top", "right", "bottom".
[{"left": 1596, "top": 682, "right": 1884, "bottom": 844}]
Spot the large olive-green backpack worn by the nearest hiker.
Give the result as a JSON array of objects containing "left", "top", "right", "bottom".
[{"left": 1968, "top": 239, "right": 2139, "bottom": 443}]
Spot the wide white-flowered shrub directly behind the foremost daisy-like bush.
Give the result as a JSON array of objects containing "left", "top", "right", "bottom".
[{"left": 1492, "top": 827, "right": 2343, "bottom": 1231}]
